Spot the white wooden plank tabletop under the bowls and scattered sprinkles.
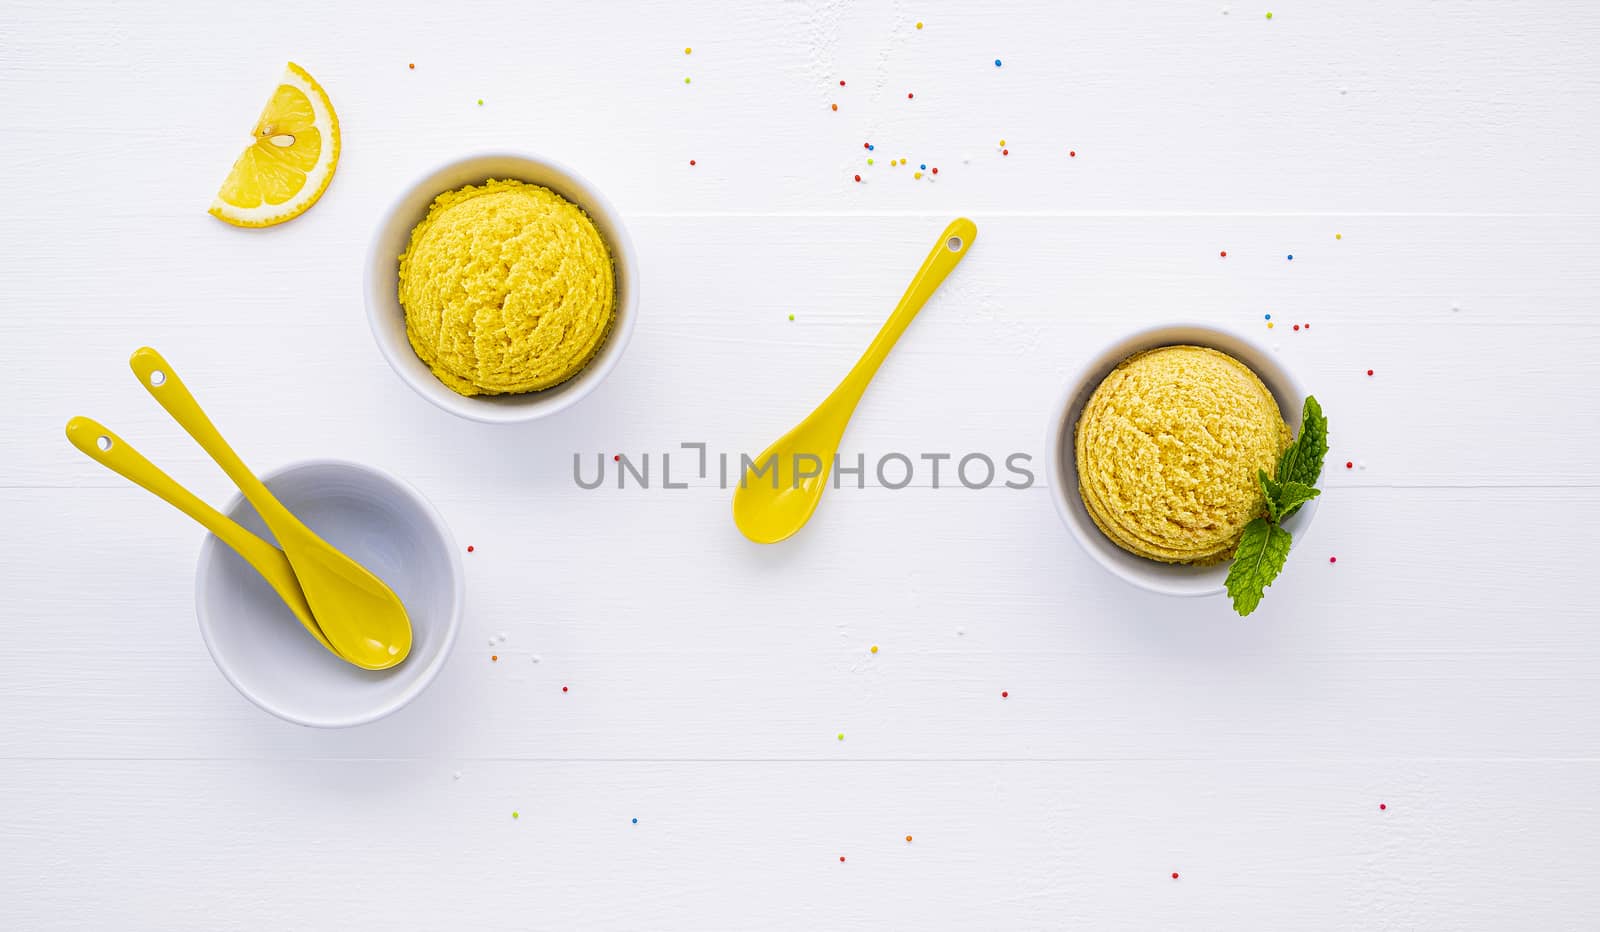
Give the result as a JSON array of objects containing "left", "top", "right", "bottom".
[{"left": 0, "top": 0, "right": 1600, "bottom": 930}]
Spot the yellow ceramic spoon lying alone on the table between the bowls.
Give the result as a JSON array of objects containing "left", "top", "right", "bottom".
[{"left": 733, "top": 218, "right": 978, "bottom": 543}]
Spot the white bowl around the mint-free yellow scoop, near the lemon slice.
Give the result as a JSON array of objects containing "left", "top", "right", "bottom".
[{"left": 366, "top": 154, "right": 638, "bottom": 423}]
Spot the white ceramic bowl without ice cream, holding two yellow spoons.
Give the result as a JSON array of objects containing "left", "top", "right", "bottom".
[{"left": 195, "top": 460, "right": 466, "bottom": 729}]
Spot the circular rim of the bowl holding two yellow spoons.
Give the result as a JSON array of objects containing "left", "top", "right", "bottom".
[{"left": 195, "top": 458, "right": 467, "bottom": 729}]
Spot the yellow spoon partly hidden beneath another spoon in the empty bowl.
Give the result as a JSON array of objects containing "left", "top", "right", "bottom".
[{"left": 67, "top": 418, "right": 342, "bottom": 660}]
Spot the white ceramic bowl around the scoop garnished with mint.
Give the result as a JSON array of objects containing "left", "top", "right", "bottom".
[{"left": 1045, "top": 323, "right": 1317, "bottom": 596}]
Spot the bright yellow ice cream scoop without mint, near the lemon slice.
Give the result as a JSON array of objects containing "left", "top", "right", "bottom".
[{"left": 400, "top": 179, "right": 616, "bottom": 396}]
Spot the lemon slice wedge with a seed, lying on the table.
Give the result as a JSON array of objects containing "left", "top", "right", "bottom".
[{"left": 211, "top": 61, "right": 339, "bottom": 226}]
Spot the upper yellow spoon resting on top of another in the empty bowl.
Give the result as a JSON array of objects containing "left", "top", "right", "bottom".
[{"left": 128, "top": 346, "right": 411, "bottom": 669}]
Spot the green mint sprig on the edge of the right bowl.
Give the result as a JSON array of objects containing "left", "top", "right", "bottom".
[{"left": 1227, "top": 396, "right": 1328, "bottom": 615}]
